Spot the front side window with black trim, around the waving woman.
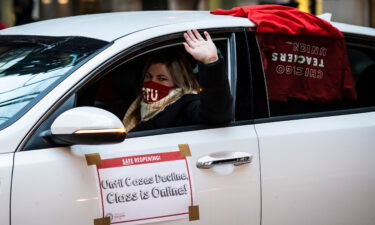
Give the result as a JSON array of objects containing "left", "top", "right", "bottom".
[{"left": 21, "top": 31, "right": 235, "bottom": 150}]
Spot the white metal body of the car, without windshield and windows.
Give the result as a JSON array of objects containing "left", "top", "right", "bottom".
[{"left": 0, "top": 11, "right": 375, "bottom": 225}]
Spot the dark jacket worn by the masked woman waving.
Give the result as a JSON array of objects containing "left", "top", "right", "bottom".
[{"left": 132, "top": 57, "right": 233, "bottom": 131}]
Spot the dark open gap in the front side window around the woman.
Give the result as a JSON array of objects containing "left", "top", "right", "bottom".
[{"left": 77, "top": 38, "right": 231, "bottom": 132}]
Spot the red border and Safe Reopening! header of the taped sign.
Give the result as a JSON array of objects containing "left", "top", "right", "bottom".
[{"left": 96, "top": 151, "right": 193, "bottom": 224}]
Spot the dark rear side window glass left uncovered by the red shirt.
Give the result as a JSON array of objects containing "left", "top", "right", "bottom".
[{"left": 253, "top": 32, "right": 375, "bottom": 118}]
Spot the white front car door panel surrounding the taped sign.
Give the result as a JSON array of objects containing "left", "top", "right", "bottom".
[{"left": 11, "top": 31, "right": 260, "bottom": 225}]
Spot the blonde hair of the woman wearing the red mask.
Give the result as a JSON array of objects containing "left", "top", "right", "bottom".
[{"left": 141, "top": 51, "right": 199, "bottom": 93}]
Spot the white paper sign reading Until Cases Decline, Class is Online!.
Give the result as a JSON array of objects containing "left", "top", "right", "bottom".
[{"left": 97, "top": 151, "right": 193, "bottom": 224}]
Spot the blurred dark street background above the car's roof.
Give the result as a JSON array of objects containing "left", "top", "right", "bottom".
[{"left": 0, "top": 0, "right": 375, "bottom": 27}]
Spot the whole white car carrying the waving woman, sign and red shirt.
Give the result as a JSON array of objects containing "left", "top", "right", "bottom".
[{"left": 0, "top": 11, "right": 375, "bottom": 225}]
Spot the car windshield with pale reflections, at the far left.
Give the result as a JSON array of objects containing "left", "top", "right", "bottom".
[{"left": 0, "top": 35, "right": 108, "bottom": 126}]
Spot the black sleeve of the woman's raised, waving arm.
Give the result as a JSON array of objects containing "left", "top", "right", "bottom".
[{"left": 186, "top": 57, "right": 233, "bottom": 124}]
